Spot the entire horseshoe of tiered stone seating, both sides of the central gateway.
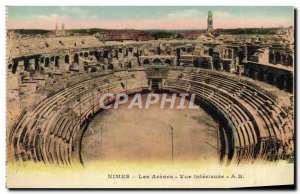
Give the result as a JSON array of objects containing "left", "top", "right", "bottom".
[{"left": 9, "top": 68, "right": 293, "bottom": 165}]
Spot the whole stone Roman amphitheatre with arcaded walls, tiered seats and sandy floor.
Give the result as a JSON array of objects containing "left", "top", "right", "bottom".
[{"left": 7, "top": 13, "right": 295, "bottom": 166}]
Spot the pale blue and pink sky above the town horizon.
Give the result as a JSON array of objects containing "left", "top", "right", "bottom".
[{"left": 7, "top": 6, "right": 294, "bottom": 30}]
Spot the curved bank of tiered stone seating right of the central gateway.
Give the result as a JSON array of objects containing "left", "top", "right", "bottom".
[{"left": 164, "top": 69, "right": 292, "bottom": 161}]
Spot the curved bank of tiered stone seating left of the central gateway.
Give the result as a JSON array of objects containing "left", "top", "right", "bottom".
[{"left": 11, "top": 71, "right": 147, "bottom": 165}]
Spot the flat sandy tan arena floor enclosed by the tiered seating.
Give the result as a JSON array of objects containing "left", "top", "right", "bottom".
[{"left": 81, "top": 94, "right": 218, "bottom": 165}]
